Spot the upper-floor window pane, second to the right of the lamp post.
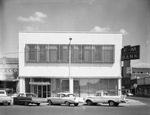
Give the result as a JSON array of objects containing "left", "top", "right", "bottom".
[{"left": 82, "top": 45, "right": 92, "bottom": 63}]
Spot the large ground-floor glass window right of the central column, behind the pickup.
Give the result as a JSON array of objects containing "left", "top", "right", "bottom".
[{"left": 74, "top": 78, "right": 118, "bottom": 97}]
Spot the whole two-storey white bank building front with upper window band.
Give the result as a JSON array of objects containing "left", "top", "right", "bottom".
[{"left": 19, "top": 33, "right": 122, "bottom": 98}]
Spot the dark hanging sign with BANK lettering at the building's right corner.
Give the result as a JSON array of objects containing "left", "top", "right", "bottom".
[{"left": 121, "top": 45, "right": 140, "bottom": 61}]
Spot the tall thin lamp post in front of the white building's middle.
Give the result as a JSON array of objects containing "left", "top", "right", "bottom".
[{"left": 69, "top": 38, "right": 73, "bottom": 93}]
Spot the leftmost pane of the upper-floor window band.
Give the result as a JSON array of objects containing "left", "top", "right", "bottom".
[{"left": 25, "top": 44, "right": 37, "bottom": 62}]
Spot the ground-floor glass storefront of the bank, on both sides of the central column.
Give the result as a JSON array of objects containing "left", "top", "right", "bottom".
[{"left": 25, "top": 78, "right": 118, "bottom": 98}]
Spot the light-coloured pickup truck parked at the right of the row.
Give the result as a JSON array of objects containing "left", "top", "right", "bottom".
[{"left": 84, "top": 91, "right": 126, "bottom": 106}]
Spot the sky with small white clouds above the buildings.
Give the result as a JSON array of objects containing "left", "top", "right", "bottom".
[{"left": 0, "top": 0, "right": 150, "bottom": 68}]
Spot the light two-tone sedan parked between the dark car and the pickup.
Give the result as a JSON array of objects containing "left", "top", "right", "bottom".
[{"left": 47, "top": 92, "right": 84, "bottom": 106}]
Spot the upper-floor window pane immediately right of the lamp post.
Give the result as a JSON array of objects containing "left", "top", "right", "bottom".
[{"left": 71, "top": 45, "right": 82, "bottom": 62}]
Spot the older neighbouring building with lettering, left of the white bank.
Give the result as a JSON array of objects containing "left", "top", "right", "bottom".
[{"left": 0, "top": 57, "right": 18, "bottom": 94}]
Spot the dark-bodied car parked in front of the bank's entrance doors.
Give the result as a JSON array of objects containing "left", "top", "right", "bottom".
[{"left": 14, "top": 93, "right": 42, "bottom": 106}]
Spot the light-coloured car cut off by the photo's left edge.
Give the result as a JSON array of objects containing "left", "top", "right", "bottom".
[{"left": 0, "top": 90, "right": 12, "bottom": 105}]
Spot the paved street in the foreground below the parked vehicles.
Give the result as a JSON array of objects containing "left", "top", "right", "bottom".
[{"left": 0, "top": 99, "right": 150, "bottom": 115}]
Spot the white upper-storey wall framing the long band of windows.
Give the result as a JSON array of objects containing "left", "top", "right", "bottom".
[{"left": 19, "top": 33, "right": 122, "bottom": 78}]
